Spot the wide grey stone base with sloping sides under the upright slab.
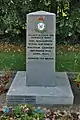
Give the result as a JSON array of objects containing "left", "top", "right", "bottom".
[{"left": 6, "top": 71, "right": 74, "bottom": 105}]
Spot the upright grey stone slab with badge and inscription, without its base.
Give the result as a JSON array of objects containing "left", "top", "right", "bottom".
[{"left": 26, "top": 11, "right": 56, "bottom": 86}]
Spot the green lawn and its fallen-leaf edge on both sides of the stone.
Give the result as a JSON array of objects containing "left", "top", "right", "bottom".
[{"left": 0, "top": 43, "right": 80, "bottom": 72}]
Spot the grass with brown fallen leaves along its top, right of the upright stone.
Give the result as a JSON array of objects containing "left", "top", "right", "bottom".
[{"left": 56, "top": 45, "right": 80, "bottom": 72}]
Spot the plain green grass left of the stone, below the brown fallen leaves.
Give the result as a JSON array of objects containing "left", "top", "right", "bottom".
[{"left": 0, "top": 52, "right": 25, "bottom": 71}]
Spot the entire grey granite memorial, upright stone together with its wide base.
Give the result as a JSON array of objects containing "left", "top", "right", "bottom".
[{"left": 6, "top": 11, "right": 74, "bottom": 105}]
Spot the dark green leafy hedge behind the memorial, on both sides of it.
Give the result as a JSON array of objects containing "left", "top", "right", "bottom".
[{"left": 0, "top": 0, "right": 80, "bottom": 44}]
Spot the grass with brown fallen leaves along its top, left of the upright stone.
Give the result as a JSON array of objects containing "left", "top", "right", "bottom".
[{"left": 0, "top": 44, "right": 26, "bottom": 71}]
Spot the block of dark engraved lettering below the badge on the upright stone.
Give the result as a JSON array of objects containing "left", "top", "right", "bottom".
[{"left": 27, "top": 34, "right": 54, "bottom": 60}]
